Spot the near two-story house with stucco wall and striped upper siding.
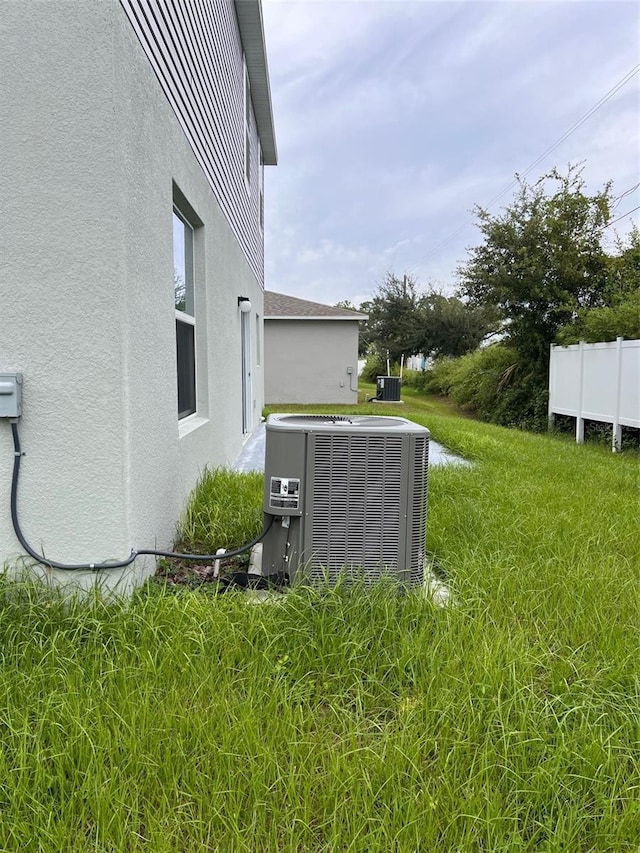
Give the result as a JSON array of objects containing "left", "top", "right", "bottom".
[{"left": 0, "top": 0, "right": 276, "bottom": 580}]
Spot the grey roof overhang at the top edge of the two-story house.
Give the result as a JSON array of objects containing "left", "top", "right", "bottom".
[{"left": 234, "top": 0, "right": 278, "bottom": 166}]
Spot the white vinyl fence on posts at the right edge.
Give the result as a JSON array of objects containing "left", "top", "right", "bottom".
[{"left": 549, "top": 338, "right": 640, "bottom": 450}]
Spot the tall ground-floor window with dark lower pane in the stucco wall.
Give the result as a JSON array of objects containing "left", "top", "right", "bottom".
[{"left": 173, "top": 208, "right": 196, "bottom": 418}]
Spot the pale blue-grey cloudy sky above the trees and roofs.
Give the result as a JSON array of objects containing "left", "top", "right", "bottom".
[{"left": 263, "top": 0, "right": 640, "bottom": 306}]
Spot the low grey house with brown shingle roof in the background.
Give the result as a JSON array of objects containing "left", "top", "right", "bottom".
[{"left": 264, "top": 291, "right": 367, "bottom": 405}]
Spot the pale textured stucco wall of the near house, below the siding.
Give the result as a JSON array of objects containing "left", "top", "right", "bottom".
[{"left": 0, "top": 0, "right": 272, "bottom": 583}]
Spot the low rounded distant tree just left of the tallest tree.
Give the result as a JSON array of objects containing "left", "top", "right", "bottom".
[{"left": 417, "top": 290, "right": 497, "bottom": 356}]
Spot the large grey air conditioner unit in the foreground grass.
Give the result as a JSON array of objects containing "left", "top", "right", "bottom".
[{"left": 262, "top": 414, "right": 429, "bottom": 586}]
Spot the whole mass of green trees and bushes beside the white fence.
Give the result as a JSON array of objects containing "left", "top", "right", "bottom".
[{"left": 348, "top": 165, "right": 640, "bottom": 428}]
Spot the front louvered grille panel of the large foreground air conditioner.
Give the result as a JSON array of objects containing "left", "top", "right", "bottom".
[{"left": 310, "top": 434, "right": 403, "bottom": 583}]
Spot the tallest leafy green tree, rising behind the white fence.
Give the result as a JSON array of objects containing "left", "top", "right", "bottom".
[{"left": 458, "top": 166, "right": 611, "bottom": 368}]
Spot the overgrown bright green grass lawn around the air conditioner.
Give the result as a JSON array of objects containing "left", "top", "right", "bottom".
[{"left": 0, "top": 389, "right": 640, "bottom": 853}]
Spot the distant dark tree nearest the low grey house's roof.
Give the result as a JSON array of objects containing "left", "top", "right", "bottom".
[{"left": 363, "top": 272, "right": 420, "bottom": 362}]
